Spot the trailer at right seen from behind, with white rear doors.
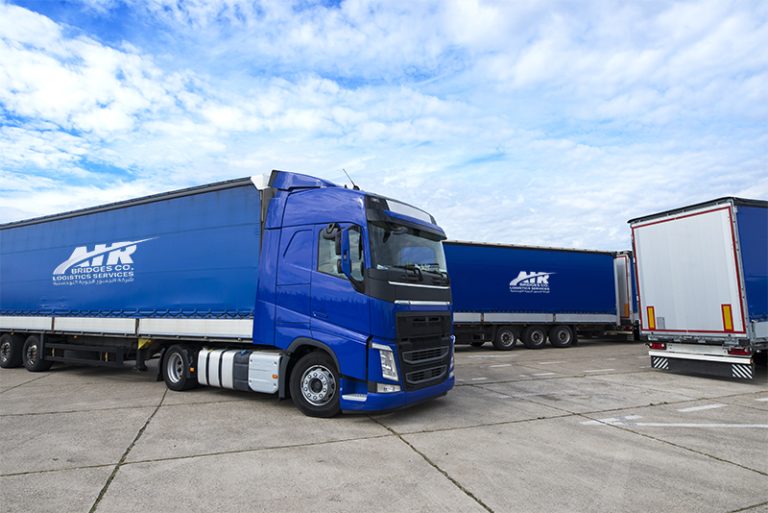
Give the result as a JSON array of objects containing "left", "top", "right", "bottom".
[{"left": 629, "top": 198, "right": 768, "bottom": 379}]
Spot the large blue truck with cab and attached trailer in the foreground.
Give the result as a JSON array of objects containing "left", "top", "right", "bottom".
[{"left": 0, "top": 171, "right": 454, "bottom": 417}]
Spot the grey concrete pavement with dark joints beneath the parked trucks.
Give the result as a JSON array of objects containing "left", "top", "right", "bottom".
[{"left": 0, "top": 341, "right": 768, "bottom": 513}]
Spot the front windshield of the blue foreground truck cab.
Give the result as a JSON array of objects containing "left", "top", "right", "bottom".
[{"left": 369, "top": 222, "right": 446, "bottom": 273}]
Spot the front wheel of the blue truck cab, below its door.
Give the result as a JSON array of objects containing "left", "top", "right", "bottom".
[{"left": 290, "top": 351, "right": 341, "bottom": 418}]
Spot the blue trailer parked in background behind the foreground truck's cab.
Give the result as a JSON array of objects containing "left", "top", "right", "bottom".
[{"left": 443, "top": 241, "right": 632, "bottom": 350}]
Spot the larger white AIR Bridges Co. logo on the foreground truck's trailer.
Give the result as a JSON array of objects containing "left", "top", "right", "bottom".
[{"left": 53, "top": 239, "right": 151, "bottom": 285}]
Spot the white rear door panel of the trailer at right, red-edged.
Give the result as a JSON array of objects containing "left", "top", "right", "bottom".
[{"left": 632, "top": 203, "right": 745, "bottom": 338}]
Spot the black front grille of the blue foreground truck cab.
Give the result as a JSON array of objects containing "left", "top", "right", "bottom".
[{"left": 397, "top": 312, "right": 451, "bottom": 390}]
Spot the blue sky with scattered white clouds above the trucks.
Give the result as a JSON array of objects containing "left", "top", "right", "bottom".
[{"left": 0, "top": 0, "right": 768, "bottom": 249}]
